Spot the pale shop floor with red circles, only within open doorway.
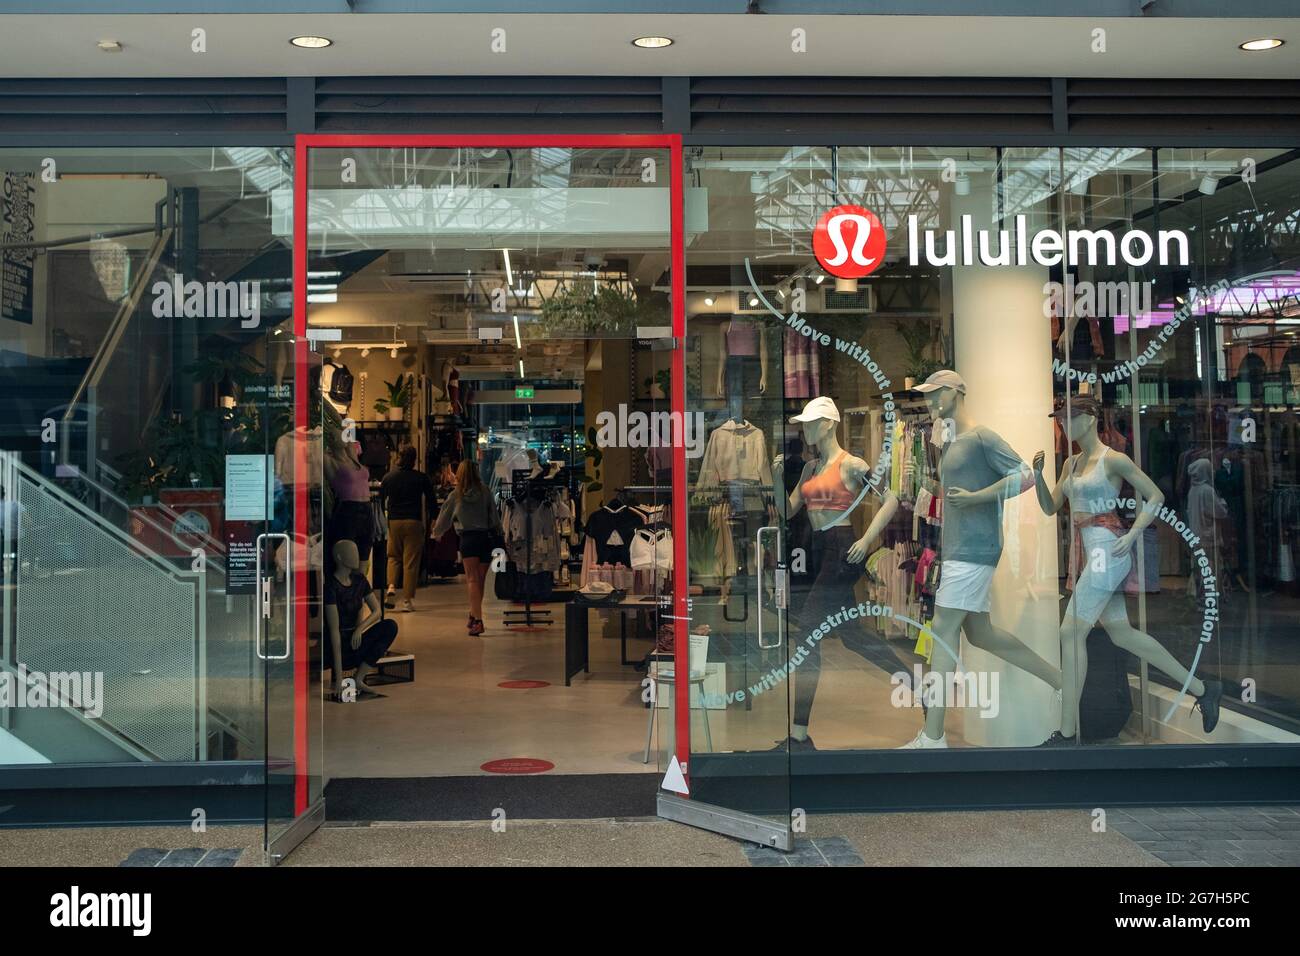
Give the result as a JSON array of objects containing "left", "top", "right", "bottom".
[{"left": 324, "top": 578, "right": 658, "bottom": 778}]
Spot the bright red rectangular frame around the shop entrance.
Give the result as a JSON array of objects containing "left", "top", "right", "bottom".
[{"left": 294, "top": 134, "right": 690, "bottom": 816}]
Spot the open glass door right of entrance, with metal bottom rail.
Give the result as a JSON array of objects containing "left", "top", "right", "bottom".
[{"left": 659, "top": 269, "right": 803, "bottom": 849}]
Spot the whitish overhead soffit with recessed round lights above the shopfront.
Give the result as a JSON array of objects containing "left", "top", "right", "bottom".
[{"left": 0, "top": 13, "right": 1300, "bottom": 78}]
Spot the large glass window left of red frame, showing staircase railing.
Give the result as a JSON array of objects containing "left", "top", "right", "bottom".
[{"left": 0, "top": 147, "right": 299, "bottom": 785}]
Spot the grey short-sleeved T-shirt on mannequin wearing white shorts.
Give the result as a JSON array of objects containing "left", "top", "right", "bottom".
[{"left": 939, "top": 425, "right": 1027, "bottom": 566}]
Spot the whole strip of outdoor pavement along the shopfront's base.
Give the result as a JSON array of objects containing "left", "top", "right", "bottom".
[{"left": 0, "top": 806, "right": 1300, "bottom": 866}]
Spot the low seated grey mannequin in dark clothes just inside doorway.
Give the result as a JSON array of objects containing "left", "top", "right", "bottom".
[{"left": 322, "top": 538, "right": 398, "bottom": 701}]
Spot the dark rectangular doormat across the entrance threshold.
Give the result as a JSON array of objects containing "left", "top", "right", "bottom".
[{"left": 325, "top": 773, "right": 659, "bottom": 822}]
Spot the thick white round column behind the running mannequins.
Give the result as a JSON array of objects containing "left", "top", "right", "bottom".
[{"left": 949, "top": 185, "right": 1061, "bottom": 747}]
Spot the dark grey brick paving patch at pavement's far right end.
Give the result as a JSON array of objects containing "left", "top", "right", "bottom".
[{"left": 1106, "top": 806, "right": 1300, "bottom": 866}]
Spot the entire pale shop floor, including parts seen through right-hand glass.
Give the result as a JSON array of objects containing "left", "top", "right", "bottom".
[{"left": 324, "top": 576, "right": 962, "bottom": 778}]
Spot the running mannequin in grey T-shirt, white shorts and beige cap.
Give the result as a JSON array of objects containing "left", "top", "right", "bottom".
[{"left": 904, "top": 369, "right": 1061, "bottom": 749}]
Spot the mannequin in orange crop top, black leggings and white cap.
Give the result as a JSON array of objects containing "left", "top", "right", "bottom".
[{"left": 772, "top": 397, "right": 898, "bottom": 750}]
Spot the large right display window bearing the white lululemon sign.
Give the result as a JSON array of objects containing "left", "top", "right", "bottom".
[{"left": 686, "top": 147, "right": 1300, "bottom": 754}]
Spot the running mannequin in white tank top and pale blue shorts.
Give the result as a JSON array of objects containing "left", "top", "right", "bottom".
[{"left": 1034, "top": 395, "right": 1223, "bottom": 747}]
